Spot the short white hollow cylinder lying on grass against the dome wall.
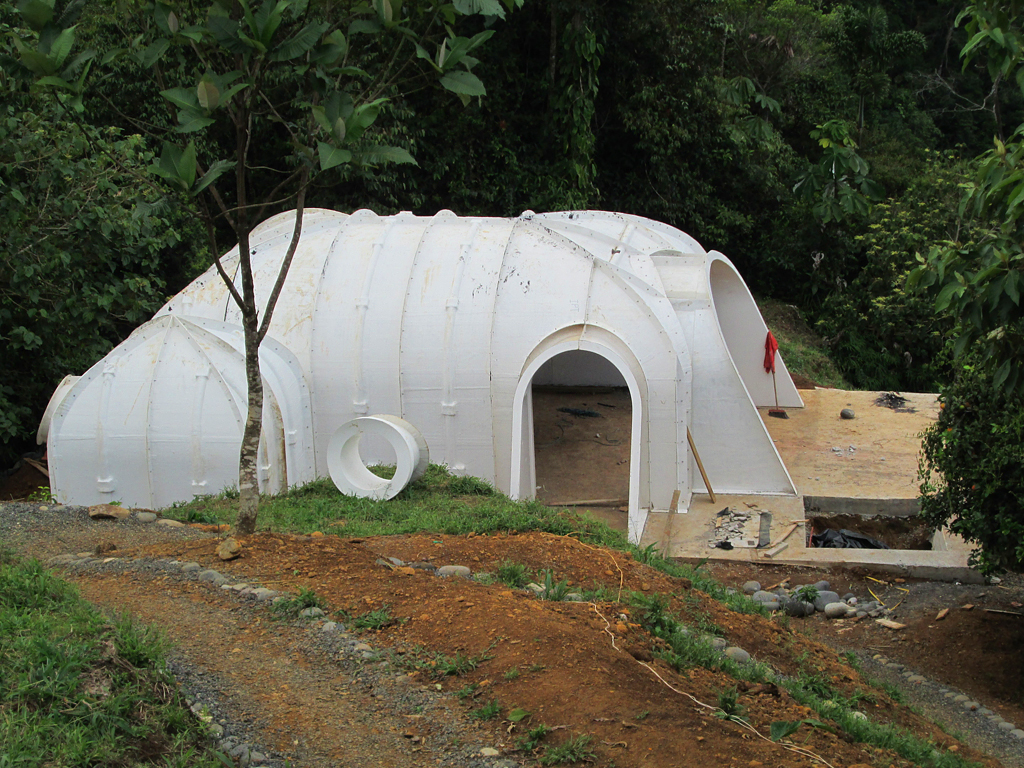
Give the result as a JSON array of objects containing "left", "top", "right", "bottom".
[{"left": 327, "top": 414, "right": 430, "bottom": 501}]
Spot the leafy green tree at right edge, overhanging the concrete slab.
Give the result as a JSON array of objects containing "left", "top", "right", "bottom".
[{"left": 909, "top": 0, "right": 1024, "bottom": 570}]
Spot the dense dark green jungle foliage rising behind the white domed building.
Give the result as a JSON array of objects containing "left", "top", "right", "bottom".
[{"left": 0, "top": 0, "right": 1024, "bottom": 565}]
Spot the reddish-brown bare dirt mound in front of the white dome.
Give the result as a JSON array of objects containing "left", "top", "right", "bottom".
[{"left": 119, "top": 534, "right": 997, "bottom": 768}]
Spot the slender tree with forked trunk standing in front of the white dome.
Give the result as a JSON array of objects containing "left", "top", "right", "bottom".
[{"left": 8, "top": 0, "right": 522, "bottom": 532}]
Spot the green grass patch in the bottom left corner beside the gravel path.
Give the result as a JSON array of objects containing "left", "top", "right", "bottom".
[{"left": 0, "top": 561, "right": 222, "bottom": 768}]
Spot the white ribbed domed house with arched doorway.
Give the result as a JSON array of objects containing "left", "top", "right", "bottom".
[{"left": 40, "top": 210, "right": 803, "bottom": 542}]
